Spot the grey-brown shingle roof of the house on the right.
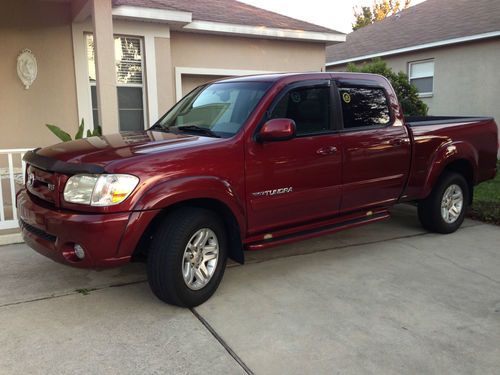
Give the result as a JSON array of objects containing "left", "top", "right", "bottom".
[{"left": 326, "top": 0, "right": 500, "bottom": 63}]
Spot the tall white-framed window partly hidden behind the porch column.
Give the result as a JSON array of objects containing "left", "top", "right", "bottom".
[{"left": 86, "top": 34, "right": 146, "bottom": 131}]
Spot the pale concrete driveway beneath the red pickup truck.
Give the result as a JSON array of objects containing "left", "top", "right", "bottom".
[{"left": 0, "top": 206, "right": 500, "bottom": 374}]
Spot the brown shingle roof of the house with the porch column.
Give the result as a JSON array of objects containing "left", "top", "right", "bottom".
[{"left": 113, "top": 0, "right": 343, "bottom": 34}]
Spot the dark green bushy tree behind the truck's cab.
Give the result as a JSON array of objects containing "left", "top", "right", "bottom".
[{"left": 347, "top": 58, "right": 429, "bottom": 116}]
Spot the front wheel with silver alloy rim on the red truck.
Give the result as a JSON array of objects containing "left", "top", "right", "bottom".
[{"left": 147, "top": 207, "right": 227, "bottom": 307}]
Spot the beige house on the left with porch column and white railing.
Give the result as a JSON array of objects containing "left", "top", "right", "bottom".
[{"left": 0, "top": 0, "right": 345, "bottom": 235}]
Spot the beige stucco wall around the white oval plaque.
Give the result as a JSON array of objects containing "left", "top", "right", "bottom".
[{"left": 0, "top": 0, "right": 78, "bottom": 149}]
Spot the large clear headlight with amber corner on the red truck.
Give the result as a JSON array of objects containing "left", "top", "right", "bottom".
[{"left": 64, "top": 174, "right": 139, "bottom": 206}]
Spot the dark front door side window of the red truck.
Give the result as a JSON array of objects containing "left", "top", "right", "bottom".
[{"left": 270, "top": 86, "right": 330, "bottom": 135}]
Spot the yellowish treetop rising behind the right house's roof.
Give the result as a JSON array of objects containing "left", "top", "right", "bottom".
[{"left": 352, "top": 0, "right": 411, "bottom": 31}]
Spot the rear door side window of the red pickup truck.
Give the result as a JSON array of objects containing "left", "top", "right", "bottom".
[{"left": 339, "top": 87, "right": 391, "bottom": 129}]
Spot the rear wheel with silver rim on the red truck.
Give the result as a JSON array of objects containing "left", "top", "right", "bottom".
[{"left": 418, "top": 172, "right": 470, "bottom": 234}]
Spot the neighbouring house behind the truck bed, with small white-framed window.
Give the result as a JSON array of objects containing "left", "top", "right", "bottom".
[{"left": 326, "top": 0, "right": 500, "bottom": 134}]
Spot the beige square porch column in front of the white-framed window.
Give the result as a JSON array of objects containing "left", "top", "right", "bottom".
[{"left": 90, "top": 0, "right": 119, "bottom": 134}]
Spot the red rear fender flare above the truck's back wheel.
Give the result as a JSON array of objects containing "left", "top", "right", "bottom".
[{"left": 422, "top": 141, "right": 479, "bottom": 198}]
